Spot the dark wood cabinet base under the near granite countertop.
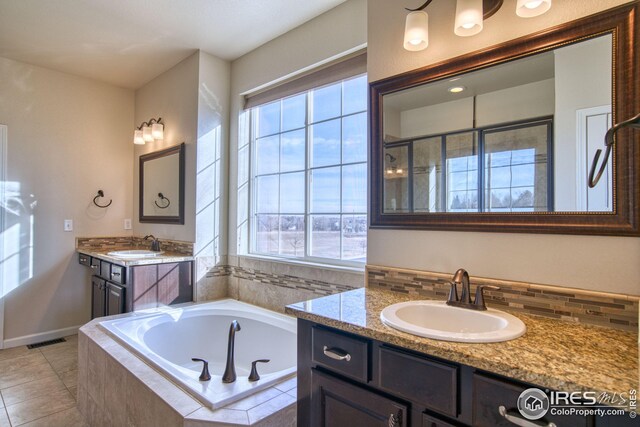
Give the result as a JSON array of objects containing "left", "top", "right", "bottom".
[{"left": 298, "top": 319, "right": 635, "bottom": 427}]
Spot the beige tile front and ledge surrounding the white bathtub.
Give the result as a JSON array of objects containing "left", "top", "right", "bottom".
[{"left": 78, "top": 313, "right": 297, "bottom": 427}]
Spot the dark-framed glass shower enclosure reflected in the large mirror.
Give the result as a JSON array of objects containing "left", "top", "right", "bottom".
[{"left": 384, "top": 118, "right": 553, "bottom": 213}]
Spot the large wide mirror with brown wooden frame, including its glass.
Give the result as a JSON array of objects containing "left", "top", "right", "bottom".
[{"left": 370, "top": 4, "right": 640, "bottom": 235}]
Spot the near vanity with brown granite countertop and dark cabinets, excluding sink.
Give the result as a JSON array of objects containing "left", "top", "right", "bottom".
[{"left": 287, "top": 288, "right": 638, "bottom": 427}]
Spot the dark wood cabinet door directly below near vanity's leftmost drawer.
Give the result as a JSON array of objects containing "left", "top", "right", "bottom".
[{"left": 310, "top": 369, "right": 408, "bottom": 427}]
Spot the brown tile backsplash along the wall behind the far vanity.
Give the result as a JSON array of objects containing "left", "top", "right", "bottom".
[{"left": 76, "top": 236, "right": 194, "bottom": 256}]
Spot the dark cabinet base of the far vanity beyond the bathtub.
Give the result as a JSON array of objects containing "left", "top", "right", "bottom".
[{"left": 78, "top": 253, "right": 193, "bottom": 319}]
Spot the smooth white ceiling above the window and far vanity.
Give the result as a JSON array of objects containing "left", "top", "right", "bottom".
[{"left": 0, "top": 0, "right": 345, "bottom": 89}]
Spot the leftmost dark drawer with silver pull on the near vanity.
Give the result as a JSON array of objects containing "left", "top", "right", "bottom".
[{"left": 311, "top": 327, "right": 369, "bottom": 382}]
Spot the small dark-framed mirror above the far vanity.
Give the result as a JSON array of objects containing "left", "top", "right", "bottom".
[{"left": 139, "top": 143, "right": 185, "bottom": 224}]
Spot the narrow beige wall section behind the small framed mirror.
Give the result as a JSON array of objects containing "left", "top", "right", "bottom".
[{"left": 136, "top": 52, "right": 199, "bottom": 242}]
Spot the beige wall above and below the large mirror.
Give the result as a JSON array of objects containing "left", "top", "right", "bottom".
[{"left": 367, "top": 0, "right": 640, "bottom": 295}]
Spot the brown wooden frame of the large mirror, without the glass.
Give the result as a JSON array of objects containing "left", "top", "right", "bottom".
[{"left": 369, "top": 2, "right": 640, "bottom": 236}]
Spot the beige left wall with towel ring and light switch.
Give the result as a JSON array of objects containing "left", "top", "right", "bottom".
[{"left": 0, "top": 58, "right": 134, "bottom": 345}]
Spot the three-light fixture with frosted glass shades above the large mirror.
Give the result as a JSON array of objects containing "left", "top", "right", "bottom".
[{"left": 404, "top": 0, "right": 551, "bottom": 52}]
